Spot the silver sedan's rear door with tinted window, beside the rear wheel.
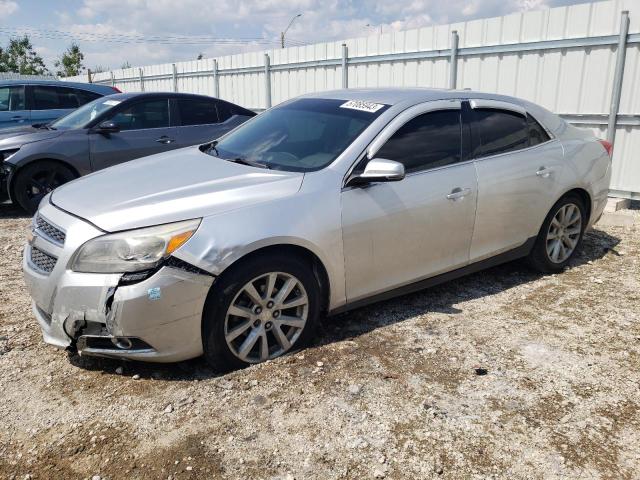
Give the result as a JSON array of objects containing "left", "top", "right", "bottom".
[{"left": 465, "top": 99, "right": 563, "bottom": 262}]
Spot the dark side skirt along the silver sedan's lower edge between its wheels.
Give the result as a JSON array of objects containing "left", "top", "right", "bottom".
[{"left": 329, "top": 237, "right": 537, "bottom": 315}]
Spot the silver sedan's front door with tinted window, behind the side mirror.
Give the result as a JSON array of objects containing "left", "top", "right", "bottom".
[{"left": 342, "top": 102, "right": 476, "bottom": 302}]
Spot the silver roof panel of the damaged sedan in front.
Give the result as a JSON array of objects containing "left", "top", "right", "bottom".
[{"left": 303, "top": 87, "right": 523, "bottom": 105}]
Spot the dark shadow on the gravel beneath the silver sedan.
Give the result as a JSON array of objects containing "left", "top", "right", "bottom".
[{"left": 69, "top": 229, "right": 620, "bottom": 381}]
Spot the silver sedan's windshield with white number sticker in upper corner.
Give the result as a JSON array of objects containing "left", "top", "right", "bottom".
[{"left": 207, "top": 98, "right": 388, "bottom": 172}]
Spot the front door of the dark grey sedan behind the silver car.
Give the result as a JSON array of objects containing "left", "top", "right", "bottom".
[{"left": 89, "top": 97, "right": 178, "bottom": 170}]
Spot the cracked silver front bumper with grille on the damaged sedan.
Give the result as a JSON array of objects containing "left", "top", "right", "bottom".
[{"left": 23, "top": 204, "right": 214, "bottom": 362}]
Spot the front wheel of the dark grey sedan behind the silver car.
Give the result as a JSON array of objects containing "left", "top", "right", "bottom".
[{"left": 12, "top": 160, "right": 77, "bottom": 215}]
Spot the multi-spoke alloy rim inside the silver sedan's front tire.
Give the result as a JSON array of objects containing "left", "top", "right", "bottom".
[{"left": 224, "top": 272, "right": 309, "bottom": 363}]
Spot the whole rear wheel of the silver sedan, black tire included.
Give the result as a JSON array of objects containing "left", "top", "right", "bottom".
[{"left": 528, "top": 193, "right": 587, "bottom": 273}]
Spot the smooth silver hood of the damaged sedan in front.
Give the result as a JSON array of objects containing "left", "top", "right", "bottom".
[{"left": 51, "top": 147, "right": 304, "bottom": 232}]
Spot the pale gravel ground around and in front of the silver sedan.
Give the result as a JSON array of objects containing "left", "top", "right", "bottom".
[{"left": 0, "top": 206, "right": 640, "bottom": 480}]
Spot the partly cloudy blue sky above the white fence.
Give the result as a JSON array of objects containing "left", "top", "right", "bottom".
[{"left": 0, "top": 0, "right": 600, "bottom": 70}]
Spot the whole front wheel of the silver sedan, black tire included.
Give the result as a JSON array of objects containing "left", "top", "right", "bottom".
[{"left": 202, "top": 254, "right": 321, "bottom": 372}]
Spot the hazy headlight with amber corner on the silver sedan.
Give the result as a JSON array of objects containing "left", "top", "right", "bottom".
[{"left": 71, "top": 219, "right": 200, "bottom": 273}]
